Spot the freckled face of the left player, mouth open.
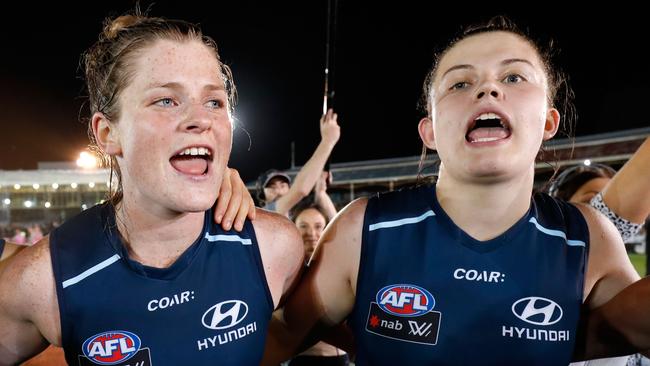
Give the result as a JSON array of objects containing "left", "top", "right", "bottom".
[{"left": 115, "top": 40, "right": 232, "bottom": 212}]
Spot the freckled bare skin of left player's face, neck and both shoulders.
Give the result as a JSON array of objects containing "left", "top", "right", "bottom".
[{"left": 0, "top": 33, "right": 303, "bottom": 365}]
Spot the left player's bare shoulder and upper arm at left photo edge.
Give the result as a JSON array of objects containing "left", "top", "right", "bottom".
[{"left": 0, "top": 238, "right": 61, "bottom": 365}]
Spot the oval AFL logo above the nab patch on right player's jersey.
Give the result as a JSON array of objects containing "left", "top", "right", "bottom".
[{"left": 376, "top": 285, "right": 436, "bottom": 317}]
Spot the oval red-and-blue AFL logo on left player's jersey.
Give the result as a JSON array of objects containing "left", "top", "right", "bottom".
[{"left": 81, "top": 330, "right": 140, "bottom": 365}]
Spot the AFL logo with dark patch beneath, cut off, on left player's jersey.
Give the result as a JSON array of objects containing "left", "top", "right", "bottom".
[{"left": 79, "top": 330, "right": 151, "bottom": 366}]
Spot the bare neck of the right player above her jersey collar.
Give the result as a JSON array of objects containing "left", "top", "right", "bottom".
[{"left": 436, "top": 169, "right": 534, "bottom": 241}]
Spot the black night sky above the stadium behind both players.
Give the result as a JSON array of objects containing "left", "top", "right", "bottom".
[{"left": 0, "top": 0, "right": 650, "bottom": 180}]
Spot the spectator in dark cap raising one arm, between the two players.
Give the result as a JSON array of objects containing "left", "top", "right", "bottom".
[{"left": 257, "top": 109, "right": 341, "bottom": 216}]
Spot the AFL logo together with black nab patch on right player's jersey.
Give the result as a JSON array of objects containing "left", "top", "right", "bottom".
[{"left": 366, "top": 284, "right": 441, "bottom": 345}]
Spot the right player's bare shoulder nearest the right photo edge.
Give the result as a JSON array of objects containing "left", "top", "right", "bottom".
[{"left": 576, "top": 204, "right": 639, "bottom": 308}]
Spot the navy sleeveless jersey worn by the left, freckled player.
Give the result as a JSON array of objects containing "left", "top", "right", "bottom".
[{"left": 50, "top": 204, "right": 273, "bottom": 366}]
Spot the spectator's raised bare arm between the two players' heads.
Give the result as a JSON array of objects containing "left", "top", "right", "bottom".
[{"left": 276, "top": 109, "right": 341, "bottom": 216}]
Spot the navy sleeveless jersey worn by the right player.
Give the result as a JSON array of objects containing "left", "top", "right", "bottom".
[{"left": 349, "top": 186, "right": 589, "bottom": 366}]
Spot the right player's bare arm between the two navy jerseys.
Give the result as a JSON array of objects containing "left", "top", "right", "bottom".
[{"left": 262, "top": 200, "right": 367, "bottom": 365}]
